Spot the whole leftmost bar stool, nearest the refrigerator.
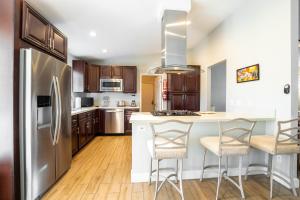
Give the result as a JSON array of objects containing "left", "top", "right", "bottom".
[{"left": 147, "top": 120, "right": 193, "bottom": 199}]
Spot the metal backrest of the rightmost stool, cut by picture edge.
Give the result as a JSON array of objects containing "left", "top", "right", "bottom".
[{"left": 275, "top": 118, "right": 300, "bottom": 152}]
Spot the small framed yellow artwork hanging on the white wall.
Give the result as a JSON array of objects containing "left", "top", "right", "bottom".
[{"left": 236, "top": 64, "right": 259, "bottom": 83}]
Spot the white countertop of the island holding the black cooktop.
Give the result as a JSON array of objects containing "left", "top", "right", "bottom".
[{"left": 130, "top": 112, "right": 274, "bottom": 123}]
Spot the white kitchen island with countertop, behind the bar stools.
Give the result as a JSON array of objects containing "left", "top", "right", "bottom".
[{"left": 130, "top": 112, "right": 275, "bottom": 183}]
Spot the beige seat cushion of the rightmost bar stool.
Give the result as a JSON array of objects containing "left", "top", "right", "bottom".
[{"left": 250, "top": 135, "right": 300, "bottom": 155}]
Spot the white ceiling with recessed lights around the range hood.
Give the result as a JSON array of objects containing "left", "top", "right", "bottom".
[{"left": 27, "top": 0, "right": 245, "bottom": 60}]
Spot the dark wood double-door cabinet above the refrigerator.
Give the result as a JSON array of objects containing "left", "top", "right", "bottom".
[{"left": 22, "top": 1, "right": 67, "bottom": 61}]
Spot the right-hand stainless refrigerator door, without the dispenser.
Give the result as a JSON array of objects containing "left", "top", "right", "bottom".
[{"left": 56, "top": 61, "right": 72, "bottom": 179}]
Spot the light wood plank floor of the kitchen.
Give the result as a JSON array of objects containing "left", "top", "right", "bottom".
[{"left": 42, "top": 136, "right": 300, "bottom": 200}]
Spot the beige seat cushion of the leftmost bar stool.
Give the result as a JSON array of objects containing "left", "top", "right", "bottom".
[{"left": 147, "top": 139, "right": 187, "bottom": 159}]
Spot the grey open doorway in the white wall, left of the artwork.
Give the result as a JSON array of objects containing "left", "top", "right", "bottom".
[{"left": 208, "top": 60, "right": 226, "bottom": 112}]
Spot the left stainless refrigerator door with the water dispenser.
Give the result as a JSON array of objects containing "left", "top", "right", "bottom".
[{"left": 20, "top": 49, "right": 57, "bottom": 200}]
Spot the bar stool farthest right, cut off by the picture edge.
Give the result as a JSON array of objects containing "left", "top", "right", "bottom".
[{"left": 245, "top": 118, "right": 300, "bottom": 199}]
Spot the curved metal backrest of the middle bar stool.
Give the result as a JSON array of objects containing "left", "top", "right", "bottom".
[{"left": 219, "top": 118, "right": 256, "bottom": 152}]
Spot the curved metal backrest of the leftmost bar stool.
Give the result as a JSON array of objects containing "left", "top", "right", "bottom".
[{"left": 150, "top": 120, "right": 193, "bottom": 157}]
